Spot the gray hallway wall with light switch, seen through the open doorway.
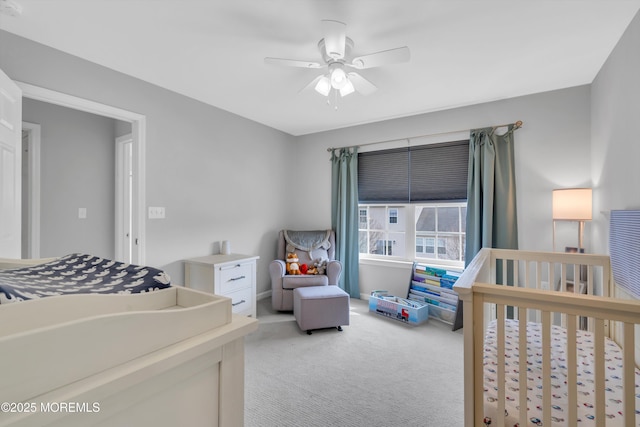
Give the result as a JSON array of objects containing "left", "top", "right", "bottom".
[{"left": 22, "top": 99, "right": 118, "bottom": 258}]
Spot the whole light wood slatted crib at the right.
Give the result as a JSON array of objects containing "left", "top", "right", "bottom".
[{"left": 454, "top": 249, "right": 640, "bottom": 427}]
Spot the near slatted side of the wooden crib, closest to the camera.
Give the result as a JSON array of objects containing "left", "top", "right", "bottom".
[{"left": 473, "top": 283, "right": 640, "bottom": 426}]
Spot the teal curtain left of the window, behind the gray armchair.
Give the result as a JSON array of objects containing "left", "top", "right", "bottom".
[{"left": 331, "top": 147, "right": 360, "bottom": 298}]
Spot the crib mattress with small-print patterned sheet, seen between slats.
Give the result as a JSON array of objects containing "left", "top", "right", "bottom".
[{"left": 483, "top": 319, "right": 640, "bottom": 427}]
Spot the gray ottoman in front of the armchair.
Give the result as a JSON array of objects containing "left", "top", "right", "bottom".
[{"left": 293, "top": 285, "right": 349, "bottom": 335}]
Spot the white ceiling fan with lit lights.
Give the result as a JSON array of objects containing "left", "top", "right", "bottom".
[{"left": 264, "top": 20, "right": 410, "bottom": 97}]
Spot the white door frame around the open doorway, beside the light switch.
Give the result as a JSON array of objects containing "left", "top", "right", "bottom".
[{"left": 14, "top": 80, "right": 146, "bottom": 264}]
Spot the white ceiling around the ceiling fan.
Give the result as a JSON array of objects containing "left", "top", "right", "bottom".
[{"left": 0, "top": 0, "right": 640, "bottom": 135}]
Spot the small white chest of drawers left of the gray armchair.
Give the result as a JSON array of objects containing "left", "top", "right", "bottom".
[{"left": 184, "top": 254, "right": 260, "bottom": 317}]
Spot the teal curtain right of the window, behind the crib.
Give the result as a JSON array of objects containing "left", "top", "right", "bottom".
[{"left": 465, "top": 125, "right": 518, "bottom": 265}]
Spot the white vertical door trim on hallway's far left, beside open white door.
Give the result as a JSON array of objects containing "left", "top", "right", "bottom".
[{"left": 22, "top": 122, "right": 42, "bottom": 258}]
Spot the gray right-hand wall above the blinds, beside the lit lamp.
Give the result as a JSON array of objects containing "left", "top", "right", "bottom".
[{"left": 591, "top": 10, "right": 640, "bottom": 253}]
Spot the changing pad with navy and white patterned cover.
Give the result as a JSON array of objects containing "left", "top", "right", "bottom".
[{"left": 0, "top": 253, "right": 171, "bottom": 304}]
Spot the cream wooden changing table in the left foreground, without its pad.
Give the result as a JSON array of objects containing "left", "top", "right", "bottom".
[{"left": 0, "top": 260, "right": 257, "bottom": 427}]
